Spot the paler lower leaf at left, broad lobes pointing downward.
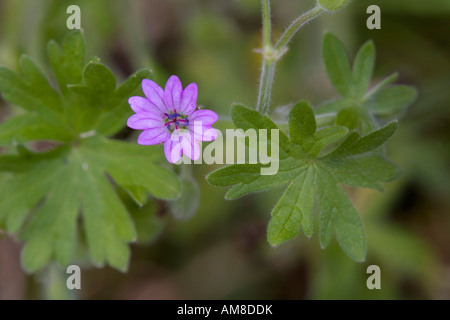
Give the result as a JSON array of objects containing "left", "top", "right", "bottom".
[{"left": 0, "top": 137, "right": 181, "bottom": 272}]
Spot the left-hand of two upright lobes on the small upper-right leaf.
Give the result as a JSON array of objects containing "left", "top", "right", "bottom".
[{"left": 322, "top": 32, "right": 353, "bottom": 97}]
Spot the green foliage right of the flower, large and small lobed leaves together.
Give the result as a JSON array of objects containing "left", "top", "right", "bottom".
[{"left": 207, "top": 33, "right": 408, "bottom": 261}]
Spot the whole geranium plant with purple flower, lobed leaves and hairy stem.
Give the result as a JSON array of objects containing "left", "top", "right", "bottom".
[{"left": 0, "top": 0, "right": 416, "bottom": 272}]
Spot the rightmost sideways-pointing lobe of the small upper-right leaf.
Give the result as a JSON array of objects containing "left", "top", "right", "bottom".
[{"left": 366, "top": 85, "right": 417, "bottom": 116}]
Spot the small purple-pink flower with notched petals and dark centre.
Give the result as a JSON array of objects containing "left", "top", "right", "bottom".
[{"left": 127, "top": 76, "right": 218, "bottom": 163}]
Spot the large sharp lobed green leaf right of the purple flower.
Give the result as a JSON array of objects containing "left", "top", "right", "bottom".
[{"left": 207, "top": 101, "right": 399, "bottom": 261}]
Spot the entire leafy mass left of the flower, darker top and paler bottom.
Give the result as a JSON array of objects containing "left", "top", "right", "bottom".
[{"left": 0, "top": 32, "right": 181, "bottom": 272}]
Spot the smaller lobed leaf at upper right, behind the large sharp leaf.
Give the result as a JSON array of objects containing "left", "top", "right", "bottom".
[{"left": 316, "top": 32, "right": 417, "bottom": 134}]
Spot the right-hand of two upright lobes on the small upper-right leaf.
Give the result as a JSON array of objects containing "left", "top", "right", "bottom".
[{"left": 353, "top": 41, "right": 375, "bottom": 99}]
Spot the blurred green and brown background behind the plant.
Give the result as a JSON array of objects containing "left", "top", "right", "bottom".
[{"left": 0, "top": 0, "right": 450, "bottom": 299}]
